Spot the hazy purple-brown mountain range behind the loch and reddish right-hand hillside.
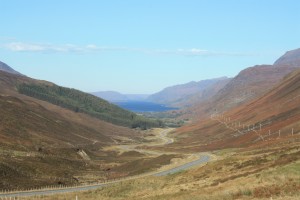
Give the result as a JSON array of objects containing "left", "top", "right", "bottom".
[{"left": 93, "top": 49, "right": 300, "bottom": 112}]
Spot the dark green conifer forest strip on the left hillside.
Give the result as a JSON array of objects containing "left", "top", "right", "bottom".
[{"left": 17, "top": 83, "right": 163, "bottom": 129}]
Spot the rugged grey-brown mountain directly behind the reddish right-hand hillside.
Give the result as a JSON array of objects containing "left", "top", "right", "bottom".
[{"left": 183, "top": 65, "right": 296, "bottom": 120}]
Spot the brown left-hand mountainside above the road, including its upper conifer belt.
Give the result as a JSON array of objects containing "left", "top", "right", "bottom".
[{"left": 0, "top": 68, "right": 146, "bottom": 189}]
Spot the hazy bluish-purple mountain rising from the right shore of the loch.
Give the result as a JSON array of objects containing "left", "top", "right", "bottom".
[{"left": 147, "top": 77, "right": 230, "bottom": 107}]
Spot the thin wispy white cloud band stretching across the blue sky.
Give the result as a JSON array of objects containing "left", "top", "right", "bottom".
[{"left": 4, "top": 42, "right": 249, "bottom": 56}]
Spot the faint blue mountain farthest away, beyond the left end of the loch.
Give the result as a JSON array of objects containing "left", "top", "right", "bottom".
[{"left": 91, "top": 91, "right": 149, "bottom": 102}]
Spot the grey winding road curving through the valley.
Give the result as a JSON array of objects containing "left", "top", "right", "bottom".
[{"left": 0, "top": 129, "right": 211, "bottom": 199}]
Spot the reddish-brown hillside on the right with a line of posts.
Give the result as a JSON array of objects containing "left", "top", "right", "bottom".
[{"left": 170, "top": 67, "right": 300, "bottom": 150}]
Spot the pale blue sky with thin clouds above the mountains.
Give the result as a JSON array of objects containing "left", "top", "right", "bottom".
[{"left": 0, "top": 0, "right": 300, "bottom": 93}]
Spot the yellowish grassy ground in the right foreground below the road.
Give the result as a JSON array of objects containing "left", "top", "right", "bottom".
[{"left": 34, "top": 139, "right": 300, "bottom": 200}]
